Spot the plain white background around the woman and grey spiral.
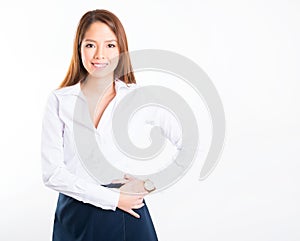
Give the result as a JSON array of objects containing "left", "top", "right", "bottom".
[{"left": 0, "top": 0, "right": 300, "bottom": 241}]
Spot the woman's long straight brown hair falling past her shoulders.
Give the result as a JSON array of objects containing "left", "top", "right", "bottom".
[{"left": 59, "top": 9, "right": 136, "bottom": 88}]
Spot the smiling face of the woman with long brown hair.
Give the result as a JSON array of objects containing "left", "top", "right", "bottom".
[{"left": 80, "top": 21, "right": 119, "bottom": 78}]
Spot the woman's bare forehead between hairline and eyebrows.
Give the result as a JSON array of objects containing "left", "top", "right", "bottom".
[{"left": 83, "top": 21, "right": 117, "bottom": 40}]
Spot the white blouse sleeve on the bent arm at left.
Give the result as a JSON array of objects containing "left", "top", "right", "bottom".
[{"left": 41, "top": 92, "right": 120, "bottom": 210}]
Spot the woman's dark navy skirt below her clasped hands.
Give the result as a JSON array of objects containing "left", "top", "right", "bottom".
[{"left": 52, "top": 193, "right": 157, "bottom": 241}]
